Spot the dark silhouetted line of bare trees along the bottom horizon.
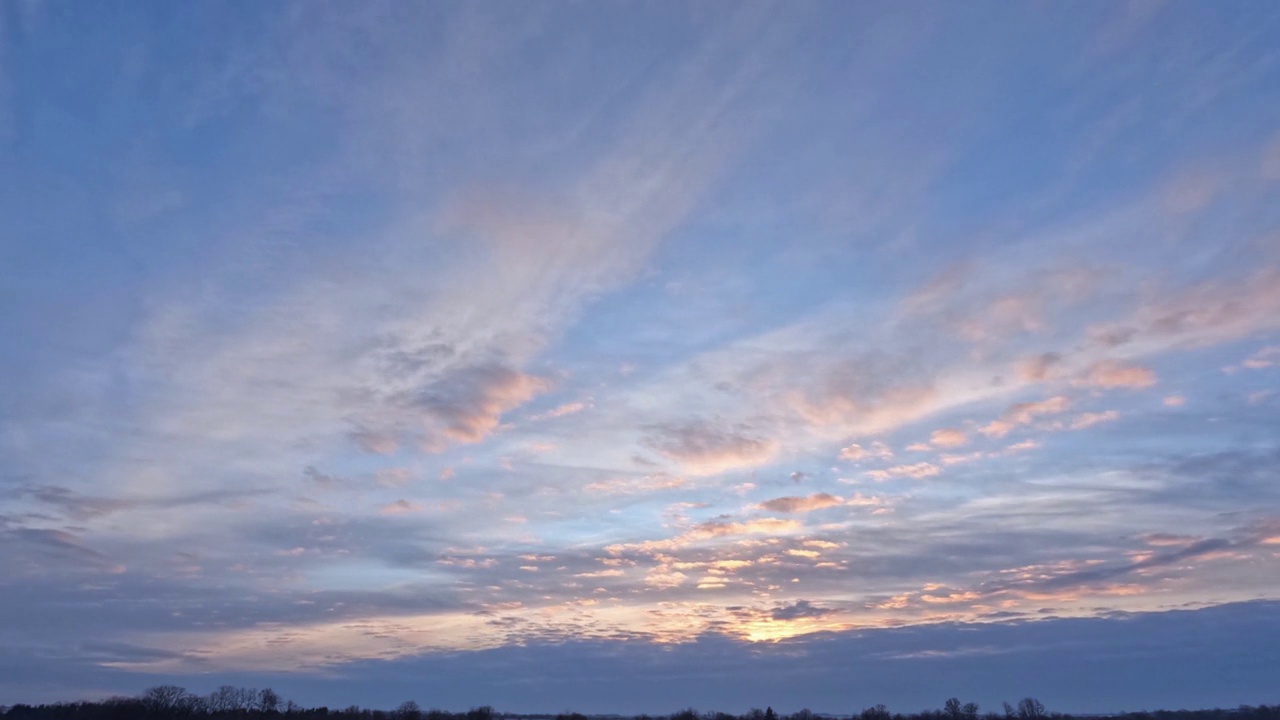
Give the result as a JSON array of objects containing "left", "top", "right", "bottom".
[{"left": 0, "top": 685, "right": 1280, "bottom": 720}]
